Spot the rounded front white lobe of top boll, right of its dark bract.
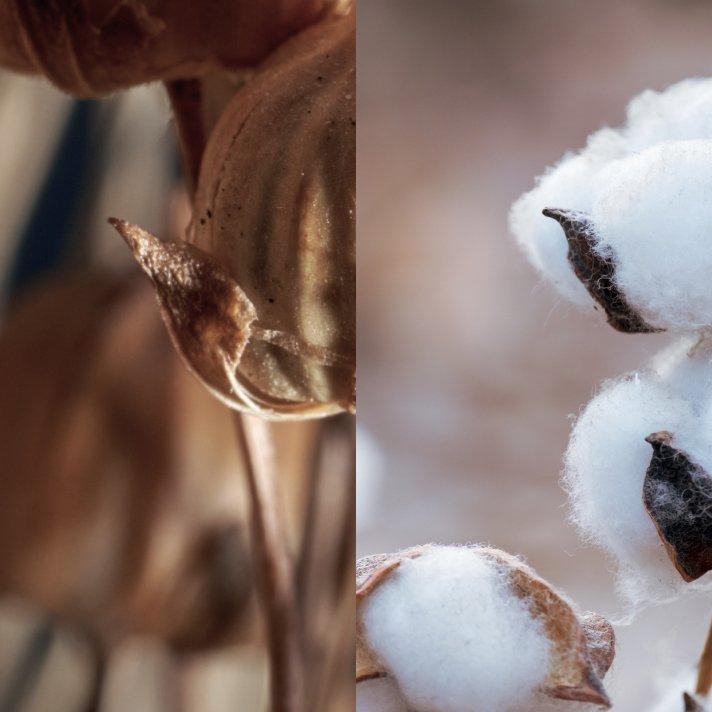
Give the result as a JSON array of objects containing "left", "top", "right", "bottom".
[{"left": 588, "top": 140, "right": 712, "bottom": 329}]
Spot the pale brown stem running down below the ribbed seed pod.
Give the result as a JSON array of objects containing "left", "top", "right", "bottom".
[{"left": 235, "top": 413, "right": 304, "bottom": 712}]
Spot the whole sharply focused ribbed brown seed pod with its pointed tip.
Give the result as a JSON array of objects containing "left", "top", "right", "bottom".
[{"left": 114, "top": 12, "right": 356, "bottom": 418}]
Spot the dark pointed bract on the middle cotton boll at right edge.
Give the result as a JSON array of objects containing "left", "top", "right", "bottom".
[{"left": 643, "top": 431, "right": 712, "bottom": 581}]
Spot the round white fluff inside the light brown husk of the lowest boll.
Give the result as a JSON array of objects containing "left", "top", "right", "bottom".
[{"left": 361, "top": 547, "right": 551, "bottom": 712}]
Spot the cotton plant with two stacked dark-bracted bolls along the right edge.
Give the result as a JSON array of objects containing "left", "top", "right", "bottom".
[{"left": 510, "top": 79, "right": 712, "bottom": 712}]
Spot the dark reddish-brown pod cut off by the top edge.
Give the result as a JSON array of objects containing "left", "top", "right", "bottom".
[{"left": 0, "top": 0, "right": 344, "bottom": 96}]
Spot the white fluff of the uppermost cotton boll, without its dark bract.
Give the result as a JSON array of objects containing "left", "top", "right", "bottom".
[{"left": 510, "top": 79, "right": 712, "bottom": 329}]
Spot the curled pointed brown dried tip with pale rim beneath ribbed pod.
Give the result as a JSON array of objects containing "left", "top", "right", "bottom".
[{"left": 109, "top": 218, "right": 352, "bottom": 419}]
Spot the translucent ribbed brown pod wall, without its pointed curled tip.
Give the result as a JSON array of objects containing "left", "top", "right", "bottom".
[{"left": 188, "top": 6, "right": 356, "bottom": 418}]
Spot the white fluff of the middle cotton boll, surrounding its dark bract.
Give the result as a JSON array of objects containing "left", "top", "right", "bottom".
[{"left": 564, "top": 339, "right": 712, "bottom": 606}]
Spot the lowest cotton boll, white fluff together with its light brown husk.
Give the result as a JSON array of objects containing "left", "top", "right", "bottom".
[{"left": 356, "top": 545, "right": 615, "bottom": 712}]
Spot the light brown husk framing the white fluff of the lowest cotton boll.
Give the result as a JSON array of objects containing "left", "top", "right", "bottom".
[{"left": 356, "top": 546, "right": 615, "bottom": 707}]
